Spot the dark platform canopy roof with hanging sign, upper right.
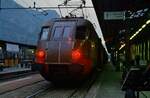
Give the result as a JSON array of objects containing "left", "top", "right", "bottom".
[{"left": 92, "top": 0, "right": 150, "bottom": 51}]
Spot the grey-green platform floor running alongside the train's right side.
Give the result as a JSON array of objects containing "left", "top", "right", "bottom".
[{"left": 85, "top": 63, "right": 125, "bottom": 98}]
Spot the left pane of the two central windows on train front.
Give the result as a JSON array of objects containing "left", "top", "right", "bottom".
[{"left": 53, "top": 26, "right": 63, "bottom": 40}]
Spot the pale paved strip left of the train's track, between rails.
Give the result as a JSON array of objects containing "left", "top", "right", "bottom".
[{"left": 0, "top": 74, "right": 45, "bottom": 95}]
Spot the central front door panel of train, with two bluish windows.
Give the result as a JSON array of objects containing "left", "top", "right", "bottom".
[{"left": 47, "top": 21, "right": 76, "bottom": 64}]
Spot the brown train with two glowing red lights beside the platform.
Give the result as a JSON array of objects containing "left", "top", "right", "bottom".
[{"left": 35, "top": 17, "right": 104, "bottom": 82}]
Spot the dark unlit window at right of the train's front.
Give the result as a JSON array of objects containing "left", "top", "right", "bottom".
[{"left": 76, "top": 26, "right": 86, "bottom": 39}]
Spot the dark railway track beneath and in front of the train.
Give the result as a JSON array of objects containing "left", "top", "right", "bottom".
[{"left": 25, "top": 70, "right": 97, "bottom": 98}]
